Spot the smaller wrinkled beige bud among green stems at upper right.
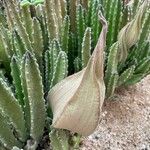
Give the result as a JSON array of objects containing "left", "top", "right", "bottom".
[{"left": 118, "top": 0, "right": 149, "bottom": 61}]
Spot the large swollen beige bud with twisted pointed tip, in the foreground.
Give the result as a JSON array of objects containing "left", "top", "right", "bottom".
[{"left": 48, "top": 14, "right": 107, "bottom": 136}]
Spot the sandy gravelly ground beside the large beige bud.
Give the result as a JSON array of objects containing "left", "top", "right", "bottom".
[{"left": 81, "top": 76, "right": 150, "bottom": 150}]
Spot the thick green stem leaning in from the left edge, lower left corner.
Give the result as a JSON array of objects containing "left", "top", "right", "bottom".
[{"left": 0, "top": 76, "right": 27, "bottom": 145}]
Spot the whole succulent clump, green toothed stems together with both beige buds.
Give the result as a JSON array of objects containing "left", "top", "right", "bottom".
[{"left": 0, "top": 0, "right": 150, "bottom": 150}]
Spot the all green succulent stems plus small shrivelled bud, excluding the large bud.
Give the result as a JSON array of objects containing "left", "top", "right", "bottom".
[{"left": 0, "top": 0, "right": 150, "bottom": 150}]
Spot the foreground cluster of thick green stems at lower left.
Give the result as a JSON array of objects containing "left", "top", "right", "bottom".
[{"left": 0, "top": 52, "right": 46, "bottom": 149}]
